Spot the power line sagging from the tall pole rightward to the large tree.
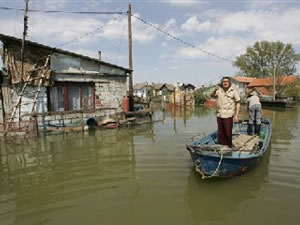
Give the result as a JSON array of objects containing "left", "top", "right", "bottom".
[{"left": 132, "top": 14, "right": 233, "bottom": 63}]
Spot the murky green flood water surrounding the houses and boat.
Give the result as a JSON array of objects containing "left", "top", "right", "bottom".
[{"left": 0, "top": 107, "right": 300, "bottom": 225}]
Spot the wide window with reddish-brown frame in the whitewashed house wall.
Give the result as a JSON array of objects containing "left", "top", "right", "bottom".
[{"left": 49, "top": 83, "right": 95, "bottom": 112}]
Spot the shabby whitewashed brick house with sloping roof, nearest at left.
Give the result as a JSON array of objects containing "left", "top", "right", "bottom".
[{"left": 0, "top": 34, "right": 131, "bottom": 135}]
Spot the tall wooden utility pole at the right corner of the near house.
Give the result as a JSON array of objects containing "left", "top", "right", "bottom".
[{"left": 128, "top": 4, "right": 134, "bottom": 111}]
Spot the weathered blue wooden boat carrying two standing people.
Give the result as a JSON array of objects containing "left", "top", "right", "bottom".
[{"left": 186, "top": 120, "right": 272, "bottom": 179}]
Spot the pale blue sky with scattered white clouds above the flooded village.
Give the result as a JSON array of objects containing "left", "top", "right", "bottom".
[{"left": 0, "top": 0, "right": 300, "bottom": 87}]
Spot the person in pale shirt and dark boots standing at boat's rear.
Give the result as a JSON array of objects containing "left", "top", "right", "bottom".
[{"left": 247, "top": 91, "right": 261, "bottom": 135}]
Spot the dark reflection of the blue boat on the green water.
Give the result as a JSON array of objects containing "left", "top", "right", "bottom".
[{"left": 186, "top": 146, "right": 270, "bottom": 224}]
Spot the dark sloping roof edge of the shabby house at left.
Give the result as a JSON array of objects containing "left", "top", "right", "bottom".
[{"left": 0, "top": 34, "right": 131, "bottom": 72}]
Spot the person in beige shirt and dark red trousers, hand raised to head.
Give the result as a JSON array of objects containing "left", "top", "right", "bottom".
[{"left": 211, "top": 77, "right": 241, "bottom": 148}]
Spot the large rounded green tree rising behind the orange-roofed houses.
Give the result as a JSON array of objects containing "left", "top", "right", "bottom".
[{"left": 233, "top": 41, "right": 300, "bottom": 78}]
